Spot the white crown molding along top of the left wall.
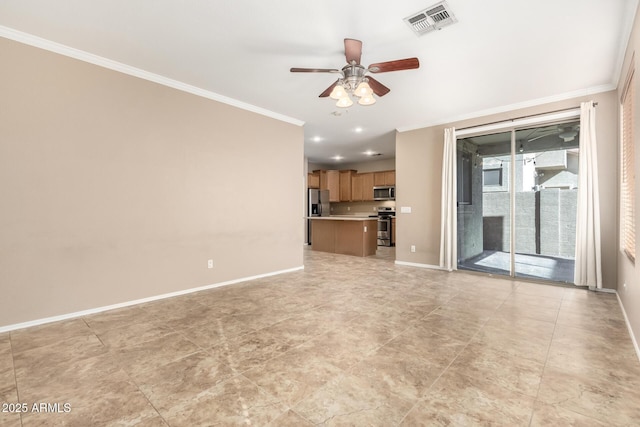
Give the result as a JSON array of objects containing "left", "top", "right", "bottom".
[{"left": 0, "top": 25, "right": 304, "bottom": 126}]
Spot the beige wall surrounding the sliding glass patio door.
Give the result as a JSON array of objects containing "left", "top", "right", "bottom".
[{"left": 396, "top": 91, "right": 618, "bottom": 289}]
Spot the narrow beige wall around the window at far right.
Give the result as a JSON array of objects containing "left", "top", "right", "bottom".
[{"left": 616, "top": 4, "right": 640, "bottom": 350}]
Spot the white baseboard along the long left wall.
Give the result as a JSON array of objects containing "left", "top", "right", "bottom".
[{"left": 0, "top": 265, "right": 304, "bottom": 333}]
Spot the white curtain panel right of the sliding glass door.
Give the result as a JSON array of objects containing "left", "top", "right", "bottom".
[{"left": 575, "top": 101, "right": 602, "bottom": 289}]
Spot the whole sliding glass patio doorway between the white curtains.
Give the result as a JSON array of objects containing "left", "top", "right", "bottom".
[{"left": 457, "top": 121, "right": 580, "bottom": 283}]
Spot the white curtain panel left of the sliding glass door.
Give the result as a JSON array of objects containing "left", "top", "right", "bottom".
[{"left": 440, "top": 128, "right": 458, "bottom": 271}]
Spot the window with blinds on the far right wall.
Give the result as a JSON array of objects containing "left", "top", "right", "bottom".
[{"left": 620, "top": 69, "right": 636, "bottom": 262}]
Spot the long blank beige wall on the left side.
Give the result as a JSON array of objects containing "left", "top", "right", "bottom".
[{"left": 0, "top": 38, "right": 304, "bottom": 327}]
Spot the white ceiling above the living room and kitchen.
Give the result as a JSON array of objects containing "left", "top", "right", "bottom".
[{"left": 0, "top": 0, "right": 638, "bottom": 163}]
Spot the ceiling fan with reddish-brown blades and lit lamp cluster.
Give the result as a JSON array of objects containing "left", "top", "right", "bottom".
[{"left": 290, "top": 38, "right": 420, "bottom": 107}]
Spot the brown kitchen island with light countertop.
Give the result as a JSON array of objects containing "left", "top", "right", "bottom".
[{"left": 309, "top": 215, "right": 378, "bottom": 257}]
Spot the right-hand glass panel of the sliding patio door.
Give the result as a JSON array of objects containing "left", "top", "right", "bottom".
[{"left": 513, "top": 122, "right": 579, "bottom": 283}]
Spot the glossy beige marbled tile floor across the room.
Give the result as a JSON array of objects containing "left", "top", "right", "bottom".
[{"left": 0, "top": 250, "right": 640, "bottom": 426}]
